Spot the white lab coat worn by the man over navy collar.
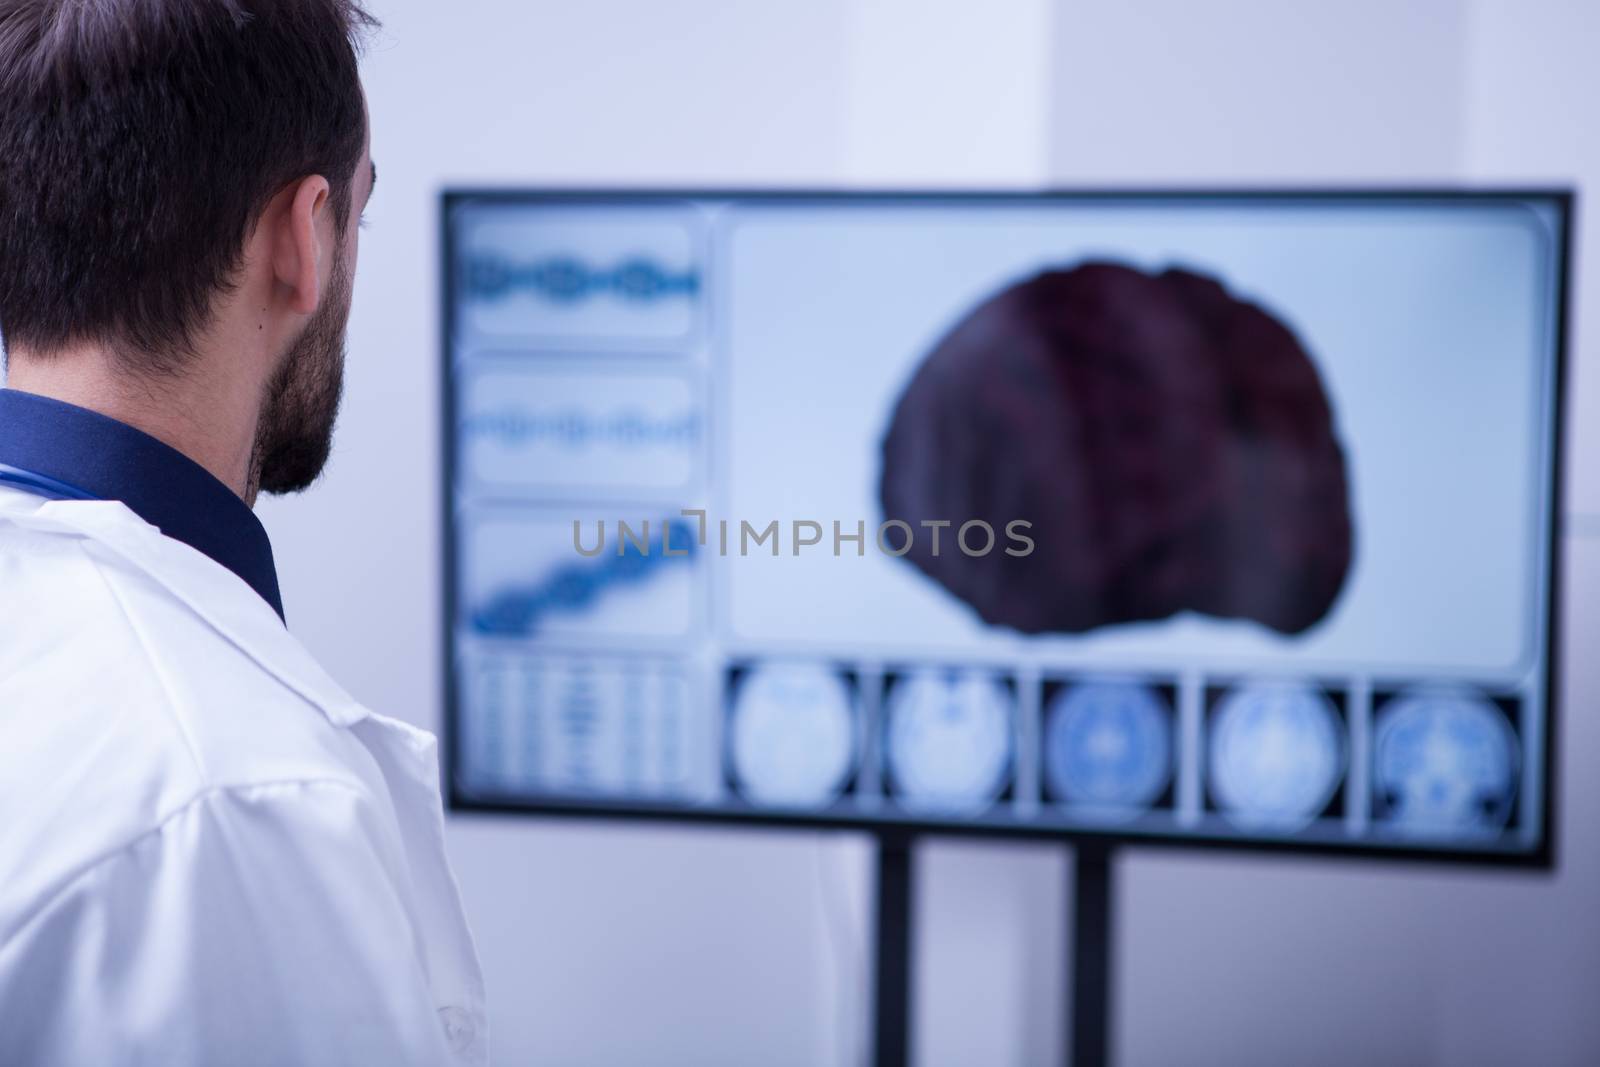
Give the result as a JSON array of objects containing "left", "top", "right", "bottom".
[{"left": 0, "top": 488, "right": 488, "bottom": 1067}]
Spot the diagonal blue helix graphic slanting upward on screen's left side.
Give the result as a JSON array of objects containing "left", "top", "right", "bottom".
[{"left": 472, "top": 518, "right": 699, "bottom": 637}]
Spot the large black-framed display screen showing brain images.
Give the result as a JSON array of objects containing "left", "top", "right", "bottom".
[{"left": 443, "top": 192, "right": 1570, "bottom": 862}]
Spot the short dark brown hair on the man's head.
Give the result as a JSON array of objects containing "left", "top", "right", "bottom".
[{"left": 0, "top": 0, "right": 376, "bottom": 371}]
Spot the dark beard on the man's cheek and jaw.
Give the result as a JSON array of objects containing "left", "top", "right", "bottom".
[{"left": 248, "top": 250, "right": 354, "bottom": 502}]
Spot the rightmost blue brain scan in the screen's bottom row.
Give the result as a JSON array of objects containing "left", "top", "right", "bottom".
[{"left": 1373, "top": 689, "right": 1518, "bottom": 837}]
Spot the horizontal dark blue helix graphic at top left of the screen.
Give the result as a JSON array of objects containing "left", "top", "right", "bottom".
[{"left": 466, "top": 254, "right": 701, "bottom": 304}]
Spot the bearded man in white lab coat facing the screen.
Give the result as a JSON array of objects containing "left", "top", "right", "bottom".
[{"left": 0, "top": 0, "right": 486, "bottom": 1067}]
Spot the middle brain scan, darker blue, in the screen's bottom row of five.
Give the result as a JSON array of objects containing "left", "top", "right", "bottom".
[{"left": 1045, "top": 680, "right": 1173, "bottom": 817}]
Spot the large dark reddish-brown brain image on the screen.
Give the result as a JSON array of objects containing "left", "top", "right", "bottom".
[{"left": 878, "top": 262, "right": 1354, "bottom": 635}]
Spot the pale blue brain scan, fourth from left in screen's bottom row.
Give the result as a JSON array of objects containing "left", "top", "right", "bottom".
[{"left": 1206, "top": 683, "right": 1346, "bottom": 832}]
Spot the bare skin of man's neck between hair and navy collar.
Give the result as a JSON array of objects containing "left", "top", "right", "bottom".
[{"left": 5, "top": 347, "right": 259, "bottom": 504}]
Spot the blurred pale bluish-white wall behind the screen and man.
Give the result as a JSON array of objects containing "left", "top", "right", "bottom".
[{"left": 264, "top": 0, "right": 1600, "bottom": 1067}]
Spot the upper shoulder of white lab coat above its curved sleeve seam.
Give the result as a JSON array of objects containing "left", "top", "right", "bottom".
[{"left": 0, "top": 525, "right": 384, "bottom": 913}]
